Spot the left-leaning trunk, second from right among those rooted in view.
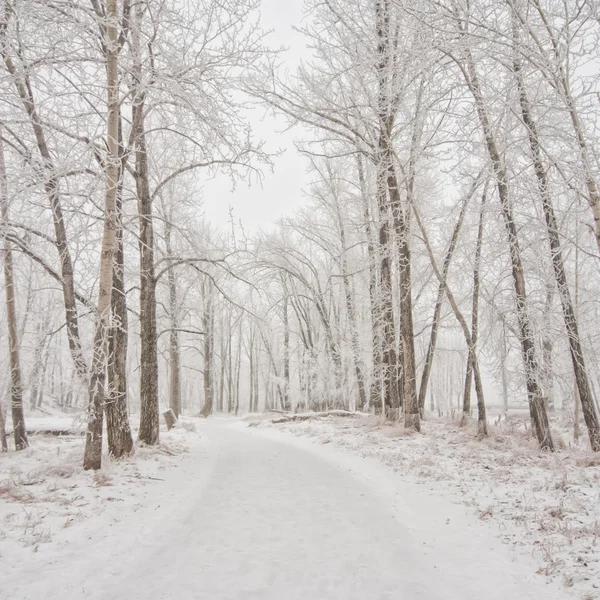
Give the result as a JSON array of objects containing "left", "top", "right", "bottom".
[{"left": 460, "top": 49, "right": 554, "bottom": 451}]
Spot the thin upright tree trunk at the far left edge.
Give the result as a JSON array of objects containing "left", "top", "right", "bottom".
[{"left": 0, "top": 126, "right": 29, "bottom": 450}]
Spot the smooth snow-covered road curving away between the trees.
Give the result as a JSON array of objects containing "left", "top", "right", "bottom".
[{"left": 0, "top": 420, "right": 565, "bottom": 600}]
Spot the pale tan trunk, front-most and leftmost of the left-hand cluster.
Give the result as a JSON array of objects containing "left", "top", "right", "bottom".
[{"left": 83, "top": 0, "right": 120, "bottom": 469}]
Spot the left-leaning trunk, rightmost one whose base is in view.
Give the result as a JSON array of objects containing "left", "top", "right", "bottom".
[{"left": 514, "top": 61, "right": 600, "bottom": 452}]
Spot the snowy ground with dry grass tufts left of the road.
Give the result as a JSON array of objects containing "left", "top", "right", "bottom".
[{"left": 0, "top": 420, "right": 197, "bottom": 562}]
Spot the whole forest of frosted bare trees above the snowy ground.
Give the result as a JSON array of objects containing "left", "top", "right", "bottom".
[{"left": 0, "top": 0, "right": 600, "bottom": 469}]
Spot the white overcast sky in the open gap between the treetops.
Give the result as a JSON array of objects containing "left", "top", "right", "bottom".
[{"left": 203, "top": 0, "right": 307, "bottom": 231}]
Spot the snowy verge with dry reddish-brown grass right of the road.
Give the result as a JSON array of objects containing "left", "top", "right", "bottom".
[{"left": 259, "top": 415, "right": 600, "bottom": 600}]
